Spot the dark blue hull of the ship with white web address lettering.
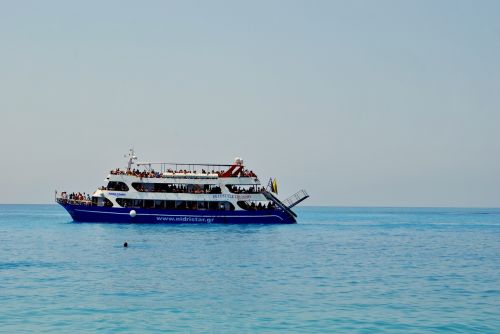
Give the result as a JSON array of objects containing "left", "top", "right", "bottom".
[{"left": 61, "top": 204, "right": 296, "bottom": 224}]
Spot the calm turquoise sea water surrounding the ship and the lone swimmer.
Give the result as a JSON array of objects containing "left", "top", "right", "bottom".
[{"left": 0, "top": 205, "right": 500, "bottom": 333}]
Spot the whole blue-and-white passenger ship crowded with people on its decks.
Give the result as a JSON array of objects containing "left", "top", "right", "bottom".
[{"left": 56, "top": 150, "right": 309, "bottom": 224}]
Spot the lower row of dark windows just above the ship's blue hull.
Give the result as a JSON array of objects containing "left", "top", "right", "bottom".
[{"left": 116, "top": 198, "right": 234, "bottom": 211}]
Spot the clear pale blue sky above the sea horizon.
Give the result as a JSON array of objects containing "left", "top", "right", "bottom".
[{"left": 0, "top": 0, "right": 500, "bottom": 207}]
